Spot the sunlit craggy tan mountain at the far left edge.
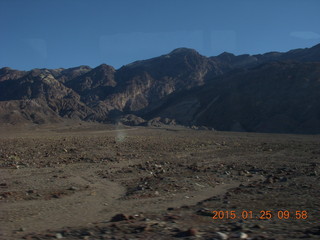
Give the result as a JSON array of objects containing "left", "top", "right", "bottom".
[{"left": 0, "top": 69, "right": 93, "bottom": 123}]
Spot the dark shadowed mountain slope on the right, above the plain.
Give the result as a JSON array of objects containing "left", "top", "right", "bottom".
[{"left": 147, "top": 62, "right": 320, "bottom": 133}]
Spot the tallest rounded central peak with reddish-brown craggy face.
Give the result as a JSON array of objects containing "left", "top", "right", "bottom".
[{"left": 106, "top": 48, "right": 222, "bottom": 112}]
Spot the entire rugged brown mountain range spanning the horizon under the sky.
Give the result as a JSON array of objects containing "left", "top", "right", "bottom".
[{"left": 0, "top": 44, "right": 320, "bottom": 134}]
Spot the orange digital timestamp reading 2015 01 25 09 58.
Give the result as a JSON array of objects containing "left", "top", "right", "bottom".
[{"left": 212, "top": 210, "right": 308, "bottom": 220}]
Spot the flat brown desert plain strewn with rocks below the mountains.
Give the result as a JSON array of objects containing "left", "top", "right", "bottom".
[{"left": 0, "top": 123, "right": 320, "bottom": 240}]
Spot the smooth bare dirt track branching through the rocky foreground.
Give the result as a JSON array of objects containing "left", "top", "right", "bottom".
[{"left": 3, "top": 162, "right": 262, "bottom": 239}]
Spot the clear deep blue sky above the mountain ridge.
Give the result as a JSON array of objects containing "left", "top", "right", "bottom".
[{"left": 0, "top": 0, "right": 320, "bottom": 70}]
